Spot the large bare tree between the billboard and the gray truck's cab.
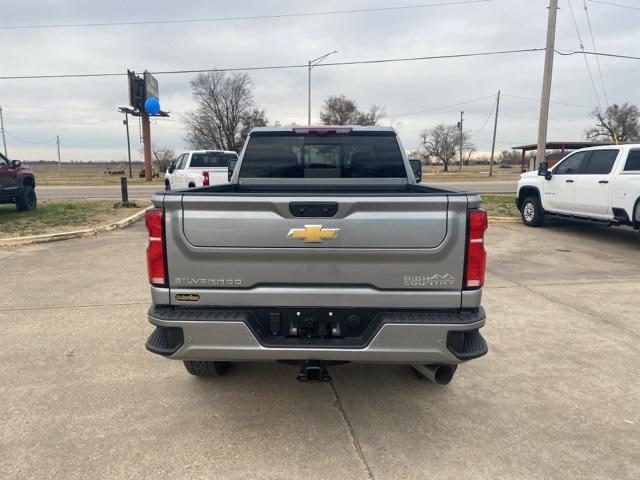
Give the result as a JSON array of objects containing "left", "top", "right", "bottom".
[{"left": 184, "top": 72, "right": 267, "bottom": 151}]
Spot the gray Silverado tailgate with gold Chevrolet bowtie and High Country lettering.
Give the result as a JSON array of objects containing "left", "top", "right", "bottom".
[{"left": 164, "top": 194, "right": 467, "bottom": 294}]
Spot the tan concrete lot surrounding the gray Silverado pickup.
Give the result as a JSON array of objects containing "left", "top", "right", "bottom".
[{"left": 0, "top": 219, "right": 640, "bottom": 480}]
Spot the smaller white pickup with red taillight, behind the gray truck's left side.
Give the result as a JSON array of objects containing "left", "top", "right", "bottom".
[{"left": 164, "top": 150, "right": 238, "bottom": 190}]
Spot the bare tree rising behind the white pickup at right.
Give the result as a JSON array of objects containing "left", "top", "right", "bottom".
[{"left": 585, "top": 103, "right": 640, "bottom": 142}]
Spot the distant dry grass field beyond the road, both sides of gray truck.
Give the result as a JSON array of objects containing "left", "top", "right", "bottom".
[{"left": 26, "top": 163, "right": 520, "bottom": 185}]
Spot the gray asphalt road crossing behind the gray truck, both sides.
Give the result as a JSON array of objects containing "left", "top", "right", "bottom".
[{"left": 37, "top": 180, "right": 517, "bottom": 198}]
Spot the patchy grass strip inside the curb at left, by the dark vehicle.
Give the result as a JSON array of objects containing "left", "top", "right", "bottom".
[{"left": 0, "top": 199, "right": 149, "bottom": 238}]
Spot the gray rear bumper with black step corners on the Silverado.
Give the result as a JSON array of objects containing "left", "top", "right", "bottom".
[{"left": 147, "top": 306, "right": 487, "bottom": 364}]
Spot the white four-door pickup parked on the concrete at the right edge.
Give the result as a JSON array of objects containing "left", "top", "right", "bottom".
[{"left": 516, "top": 144, "right": 640, "bottom": 229}]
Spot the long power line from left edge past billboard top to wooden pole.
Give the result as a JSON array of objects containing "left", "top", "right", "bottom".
[{"left": 0, "top": 48, "right": 544, "bottom": 80}]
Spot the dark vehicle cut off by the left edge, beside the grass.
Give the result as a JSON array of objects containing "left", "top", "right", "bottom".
[{"left": 0, "top": 154, "right": 38, "bottom": 210}]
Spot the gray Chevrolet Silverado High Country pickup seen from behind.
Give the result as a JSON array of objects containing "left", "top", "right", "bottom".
[{"left": 146, "top": 127, "right": 487, "bottom": 384}]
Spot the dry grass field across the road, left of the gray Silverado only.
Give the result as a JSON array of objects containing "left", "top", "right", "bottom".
[{"left": 25, "top": 162, "right": 163, "bottom": 185}]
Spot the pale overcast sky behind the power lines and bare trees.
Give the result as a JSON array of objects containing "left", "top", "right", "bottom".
[{"left": 0, "top": 0, "right": 640, "bottom": 161}]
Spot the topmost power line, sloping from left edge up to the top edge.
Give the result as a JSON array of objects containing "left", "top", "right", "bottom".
[{"left": 0, "top": 0, "right": 492, "bottom": 30}]
